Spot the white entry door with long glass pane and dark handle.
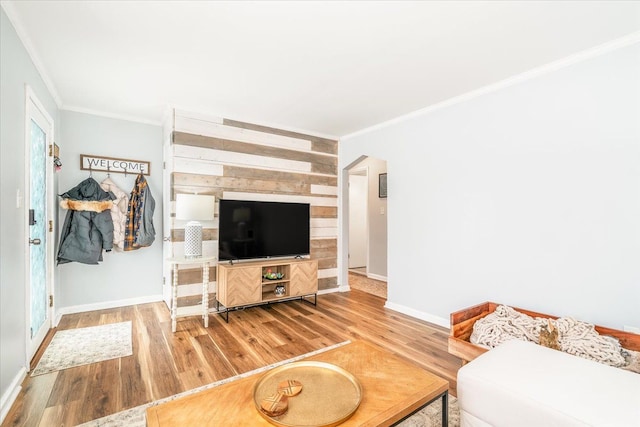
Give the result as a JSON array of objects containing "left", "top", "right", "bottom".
[{"left": 25, "top": 87, "right": 54, "bottom": 366}]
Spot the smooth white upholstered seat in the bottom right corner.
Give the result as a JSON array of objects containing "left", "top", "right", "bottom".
[{"left": 457, "top": 340, "right": 640, "bottom": 427}]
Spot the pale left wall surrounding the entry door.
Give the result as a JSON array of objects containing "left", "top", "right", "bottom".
[{"left": 0, "top": 8, "right": 59, "bottom": 422}]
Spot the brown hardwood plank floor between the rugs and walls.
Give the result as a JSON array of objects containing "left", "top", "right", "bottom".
[{"left": 2, "top": 290, "right": 461, "bottom": 426}]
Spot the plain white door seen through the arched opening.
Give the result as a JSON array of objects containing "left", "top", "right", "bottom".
[{"left": 349, "top": 170, "right": 369, "bottom": 268}]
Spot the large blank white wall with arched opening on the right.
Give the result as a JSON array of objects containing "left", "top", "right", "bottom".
[{"left": 339, "top": 44, "right": 640, "bottom": 328}]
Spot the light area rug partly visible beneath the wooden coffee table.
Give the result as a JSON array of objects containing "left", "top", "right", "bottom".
[{"left": 78, "top": 341, "right": 460, "bottom": 427}]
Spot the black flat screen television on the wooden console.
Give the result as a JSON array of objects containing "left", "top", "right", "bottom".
[{"left": 218, "top": 199, "right": 310, "bottom": 260}]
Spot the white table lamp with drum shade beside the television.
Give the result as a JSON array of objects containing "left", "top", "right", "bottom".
[{"left": 176, "top": 194, "right": 215, "bottom": 258}]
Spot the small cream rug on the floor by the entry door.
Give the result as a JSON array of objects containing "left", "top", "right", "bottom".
[{"left": 31, "top": 321, "right": 133, "bottom": 377}]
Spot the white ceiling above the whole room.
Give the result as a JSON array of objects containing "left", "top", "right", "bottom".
[{"left": 2, "top": 1, "right": 640, "bottom": 137}]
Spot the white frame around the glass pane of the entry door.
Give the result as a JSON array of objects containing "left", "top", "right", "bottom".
[{"left": 23, "top": 85, "right": 56, "bottom": 371}]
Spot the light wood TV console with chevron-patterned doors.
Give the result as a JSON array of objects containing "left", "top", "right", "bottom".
[{"left": 216, "top": 259, "right": 318, "bottom": 322}]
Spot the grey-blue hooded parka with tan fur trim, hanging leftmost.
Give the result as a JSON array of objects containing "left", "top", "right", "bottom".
[{"left": 58, "top": 178, "right": 114, "bottom": 264}]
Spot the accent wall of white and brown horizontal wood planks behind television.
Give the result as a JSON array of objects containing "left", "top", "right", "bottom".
[{"left": 167, "top": 111, "right": 338, "bottom": 306}]
